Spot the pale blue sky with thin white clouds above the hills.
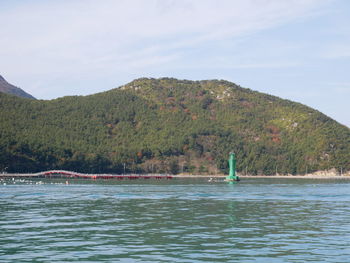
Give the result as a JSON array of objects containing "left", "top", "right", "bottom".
[{"left": 0, "top": 0, "right": 350, "bottom": 127}]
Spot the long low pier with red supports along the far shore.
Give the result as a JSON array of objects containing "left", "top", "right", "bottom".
[{"left": 0, "top": 170, "right": 173, "bottom": 180}]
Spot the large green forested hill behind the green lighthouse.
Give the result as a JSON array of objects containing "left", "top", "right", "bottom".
[{"left": 0, "top": 78, "right": 350, "bottom": 174}]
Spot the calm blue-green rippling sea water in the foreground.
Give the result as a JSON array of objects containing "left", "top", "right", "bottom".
[{"left": 0, "top": 179, "right": 350, "bottom": 262}]
